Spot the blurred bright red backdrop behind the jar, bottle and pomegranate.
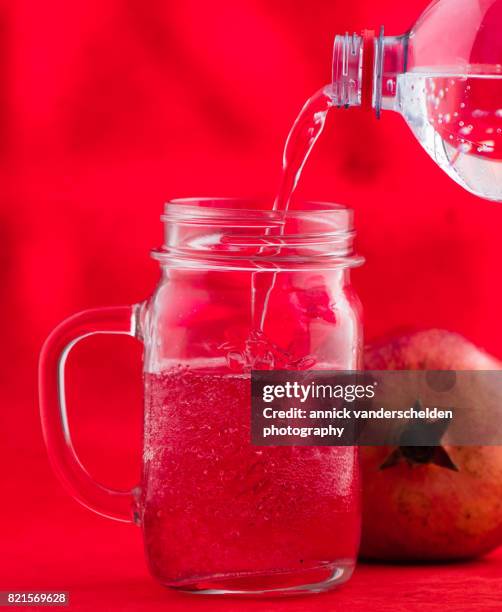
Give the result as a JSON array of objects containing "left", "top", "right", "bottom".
[{"left": 0, "top": 0, "right": 502, "bottom": 610}]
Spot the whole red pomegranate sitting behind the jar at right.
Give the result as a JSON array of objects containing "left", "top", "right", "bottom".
[{"left": 361, "top": 330, "right": 502, "bottom": 561}]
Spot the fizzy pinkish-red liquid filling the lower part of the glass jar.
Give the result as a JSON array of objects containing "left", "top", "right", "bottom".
[{"left": 143, "top": 366, "right": 360, "bottom": 590}]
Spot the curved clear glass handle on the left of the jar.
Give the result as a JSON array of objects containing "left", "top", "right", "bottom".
[{"left": 39, "top": 304, "right": 140, "bottom": 523}]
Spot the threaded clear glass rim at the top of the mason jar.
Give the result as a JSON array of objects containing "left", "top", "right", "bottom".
[{"left": 152, "top": 197, "right": 363, "bottom": 270}]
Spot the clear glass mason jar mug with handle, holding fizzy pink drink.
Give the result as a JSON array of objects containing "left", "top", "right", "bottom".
[{"left": 40, "top": 199, "right": 362, "bottom": 594}]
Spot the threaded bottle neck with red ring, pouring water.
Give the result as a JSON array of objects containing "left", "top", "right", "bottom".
[{"left": 332, "top": 27, "right": 408, "bottom": 117}]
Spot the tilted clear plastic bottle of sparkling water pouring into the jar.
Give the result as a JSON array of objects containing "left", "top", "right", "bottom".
[{"left": 333, "top": 0, "right": 502, "bottom": 202}]
